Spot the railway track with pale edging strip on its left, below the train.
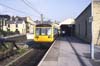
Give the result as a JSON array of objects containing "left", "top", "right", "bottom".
[{"left": 0, "top": 41, "right": 52, "bottom": 66}]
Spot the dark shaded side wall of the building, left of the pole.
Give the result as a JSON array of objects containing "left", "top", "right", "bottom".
[{"left": 75, "top": 4, "right": 91, "bottom": 42}]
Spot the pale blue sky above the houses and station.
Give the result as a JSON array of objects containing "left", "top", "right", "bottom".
[{"left": 0, "top": 0, "right": 91, "bottom": 21}]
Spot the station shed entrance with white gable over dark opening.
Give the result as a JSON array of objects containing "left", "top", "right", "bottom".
[{"left": 59, "top": 18, "right": 75, "bottom": 36}]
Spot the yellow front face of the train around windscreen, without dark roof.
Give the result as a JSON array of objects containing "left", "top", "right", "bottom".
[{"left": 34, "top": 26, "right": 54, "bottom": 42}]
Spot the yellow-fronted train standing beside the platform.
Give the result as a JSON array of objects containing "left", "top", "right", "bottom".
[{"left": 33, "top": 24, "right": 58, "bottom": 42}]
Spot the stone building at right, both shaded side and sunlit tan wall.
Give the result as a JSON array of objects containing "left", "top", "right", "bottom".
[{"left": 75, "top": 0, "right": 100, "bottom": 45}]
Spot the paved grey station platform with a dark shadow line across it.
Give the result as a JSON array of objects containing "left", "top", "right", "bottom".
[{"left": 38, "top": 37, "right": 100, "bottom": 66}]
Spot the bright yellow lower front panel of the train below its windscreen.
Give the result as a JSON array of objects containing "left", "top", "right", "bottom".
[{"left": 34, "top": 35, "right": 54, "bottom": 42}]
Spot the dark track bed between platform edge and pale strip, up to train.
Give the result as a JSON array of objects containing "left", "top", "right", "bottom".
[{"left": 19, "top": 43, "right": 51, "bottom": 66}]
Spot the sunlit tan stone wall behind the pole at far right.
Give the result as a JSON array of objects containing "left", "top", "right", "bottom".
[{"left": 93, "top": 0, "right": 100, "bottom": 45}]
